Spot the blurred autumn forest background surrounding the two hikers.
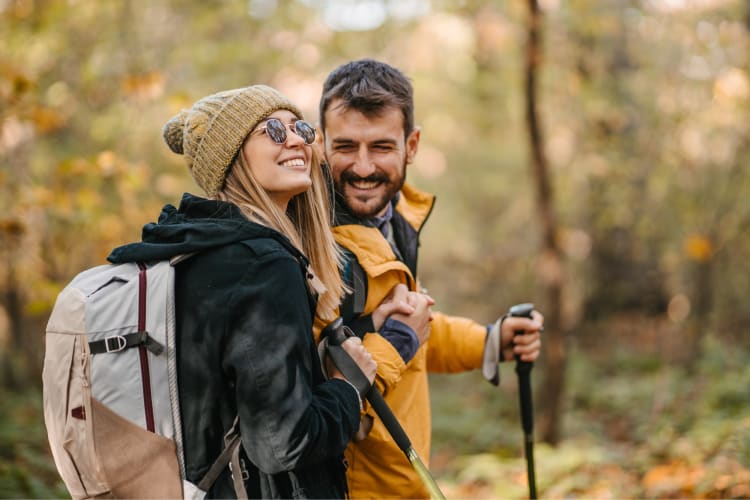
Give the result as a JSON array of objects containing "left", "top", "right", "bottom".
[{"left": 0, "top": 0, "right": 750, "bottom": 498}]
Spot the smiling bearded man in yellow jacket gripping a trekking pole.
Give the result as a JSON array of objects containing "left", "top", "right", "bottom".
[{"left": 320, "top": 59, "right": 543, "bottom": 498}]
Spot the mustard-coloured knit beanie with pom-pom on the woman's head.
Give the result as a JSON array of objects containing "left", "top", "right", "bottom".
[{"left": 162, "top": 85, "right": 303, "bottom": 197}]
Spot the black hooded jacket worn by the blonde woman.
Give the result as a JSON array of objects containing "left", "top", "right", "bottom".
[{"left": 108, "top": 194, "right": 359, "bottom": 498}]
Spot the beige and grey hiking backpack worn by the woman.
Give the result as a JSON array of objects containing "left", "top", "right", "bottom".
[{"left": 42, "top": 256, "right": 244, "bottom": 499}]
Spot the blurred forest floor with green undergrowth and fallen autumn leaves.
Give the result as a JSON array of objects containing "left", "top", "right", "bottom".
[{"left": 0, "top": 326, "right": 750, "bottom": 499}]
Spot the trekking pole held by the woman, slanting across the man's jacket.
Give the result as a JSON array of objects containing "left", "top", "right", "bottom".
[{"left": 321, "top": 318, "right": 445, "bottom": 500}]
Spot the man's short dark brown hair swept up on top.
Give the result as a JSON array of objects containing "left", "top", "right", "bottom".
[{"left": 319, "top": 59, "right": 414, "bottom": 137}]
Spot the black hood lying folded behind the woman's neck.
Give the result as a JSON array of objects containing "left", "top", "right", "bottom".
[{"left": 107, "top": 193, "right": 304, "bottom": 264}]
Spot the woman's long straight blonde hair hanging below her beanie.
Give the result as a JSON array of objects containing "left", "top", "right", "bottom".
[{"left": 216, "top": 148, "right": 345, "bottom": 321}]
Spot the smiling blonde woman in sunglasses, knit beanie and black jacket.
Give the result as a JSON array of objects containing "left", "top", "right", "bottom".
[{"left": 109, "top": 85, "right": 375, "bottom": 498}]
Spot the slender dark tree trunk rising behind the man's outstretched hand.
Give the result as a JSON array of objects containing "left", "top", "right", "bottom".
[{"left": 525, "top": 0, "right": 565, "bottom": 444}]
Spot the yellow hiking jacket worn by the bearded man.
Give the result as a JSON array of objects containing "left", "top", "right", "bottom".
[{"left": 320, "top": 184, "right": 487, "bottom": 498}]
